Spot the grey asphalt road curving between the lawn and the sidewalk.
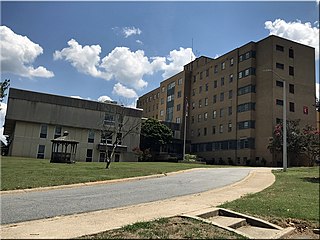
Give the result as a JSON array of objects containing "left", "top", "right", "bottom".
[{"left": 1, "top": 168, "right": 252, "bottom": 224}]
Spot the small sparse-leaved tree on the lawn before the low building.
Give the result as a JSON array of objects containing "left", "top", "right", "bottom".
[{"left": 101, "top": 106, "right": 141, "bottom": 168}]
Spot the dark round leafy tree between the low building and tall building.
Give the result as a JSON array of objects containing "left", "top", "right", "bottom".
[{"left": 140, "top": 118, "right": 173, "bottom": 152}]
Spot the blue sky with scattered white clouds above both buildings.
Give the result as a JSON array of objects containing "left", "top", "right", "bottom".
[{"left": 0, "top": 1, "right": 319, "bottom": 141}]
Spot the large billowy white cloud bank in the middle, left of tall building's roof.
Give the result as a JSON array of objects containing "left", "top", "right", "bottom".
[{"left": 54, "top": 39, "right": 194, "bottom": 90}]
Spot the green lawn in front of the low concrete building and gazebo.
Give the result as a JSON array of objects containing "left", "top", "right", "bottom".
[{"left": 1, "top": 157, "right": 219, "bottom": 191}]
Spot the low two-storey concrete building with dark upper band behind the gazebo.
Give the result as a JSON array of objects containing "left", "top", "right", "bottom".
[{"left": 4, "top": 88, "right": 142, "bottom": 162}]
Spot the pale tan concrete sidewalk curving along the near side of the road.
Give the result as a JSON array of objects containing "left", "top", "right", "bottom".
[{"left": 1, "top": 168, "right": 275, "bottom": 239}]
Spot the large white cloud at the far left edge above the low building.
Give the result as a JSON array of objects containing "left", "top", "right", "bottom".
[{"left": 0, "top": 26, "right": 54, "bottom": 78}]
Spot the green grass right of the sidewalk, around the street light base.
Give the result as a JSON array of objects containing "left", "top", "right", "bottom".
[{"left": 220, "top": 167, "right": 320, "bottom": 226}]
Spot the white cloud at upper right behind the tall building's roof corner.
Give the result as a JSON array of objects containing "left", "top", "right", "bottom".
[{"left": 265, "top": 19, "right": 319, "bottom": 60}]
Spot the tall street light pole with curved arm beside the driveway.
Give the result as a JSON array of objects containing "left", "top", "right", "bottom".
[{"left": 262, "top": 69, "right": 288, "bottom": 172}]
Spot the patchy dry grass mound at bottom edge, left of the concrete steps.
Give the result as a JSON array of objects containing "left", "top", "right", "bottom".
[{"left": 81, "top": 217, "right": 243, "bottom": 239}]
